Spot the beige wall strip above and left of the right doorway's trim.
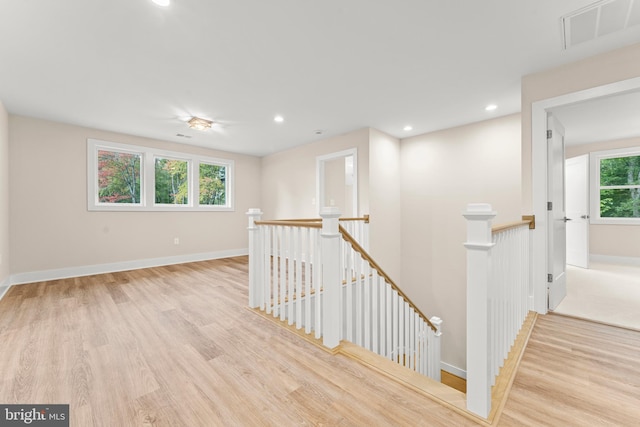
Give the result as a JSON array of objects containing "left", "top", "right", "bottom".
[{"left": 522, "top": 43, "right": 640, "bottom": 213}]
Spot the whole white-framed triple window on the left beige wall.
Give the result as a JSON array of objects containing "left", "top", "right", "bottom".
[{"left": 87, "top": 139, "right": 234, "bottom": 211}]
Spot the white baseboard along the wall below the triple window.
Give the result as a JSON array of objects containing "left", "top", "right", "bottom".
[{"left": 10, "top": 249, "right": 249, "bottom": 285}]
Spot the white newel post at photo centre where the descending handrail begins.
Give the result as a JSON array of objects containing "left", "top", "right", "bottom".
[{"left": 320, "top": 207, "right": 341, "bottom": 348}]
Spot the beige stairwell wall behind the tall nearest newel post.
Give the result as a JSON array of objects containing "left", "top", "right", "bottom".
[{"left": 400, "top": 114, "right": 521, "bottom": 369}]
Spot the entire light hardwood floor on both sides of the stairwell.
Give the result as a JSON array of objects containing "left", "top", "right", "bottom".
[{"left": 0, "top": 257, "right": 640, "bottom": 427}]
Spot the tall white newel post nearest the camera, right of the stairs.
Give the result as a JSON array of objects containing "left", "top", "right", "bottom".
[{"left": 463, "top": 203, "right": 496, "bottom": 418}]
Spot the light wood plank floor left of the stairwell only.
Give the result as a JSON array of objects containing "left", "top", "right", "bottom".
[{"left": 0, "top": 257, "right": 474, "bottom": 427}]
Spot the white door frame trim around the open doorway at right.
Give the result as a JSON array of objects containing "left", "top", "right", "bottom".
[{"left": 530, "top": 77, "right": 640, "bottom": 314}]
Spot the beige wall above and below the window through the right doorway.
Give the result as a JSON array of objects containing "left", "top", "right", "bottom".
[{"left": 566, "top": 137, "right": 640, "bottom": 258}]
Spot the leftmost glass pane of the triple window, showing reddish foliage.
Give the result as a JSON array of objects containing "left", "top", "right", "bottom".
[{"left": 98, "top": 150, "right": 141, "bottom": 204}]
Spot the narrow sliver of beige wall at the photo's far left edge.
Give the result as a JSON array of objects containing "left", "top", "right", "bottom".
[{"left": 0, "top": 101, "right": 10, "bottom": 286}]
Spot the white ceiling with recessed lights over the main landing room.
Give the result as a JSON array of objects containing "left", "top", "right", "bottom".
[{"left": 0, "top": 0, "right": 640, "bottom": 155}]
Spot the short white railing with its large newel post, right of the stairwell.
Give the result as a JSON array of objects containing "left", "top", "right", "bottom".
[{"left": 464, "top": 204, "right": 533, "bottom": 418}]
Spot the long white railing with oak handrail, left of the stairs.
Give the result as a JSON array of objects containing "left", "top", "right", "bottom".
[{"left": 248, "top": 208, "right": 442, "bottom": 380}]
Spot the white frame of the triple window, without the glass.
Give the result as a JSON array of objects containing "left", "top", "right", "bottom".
[{"left": 87, "top": 138, "right": 235, "bottom": 212}]
